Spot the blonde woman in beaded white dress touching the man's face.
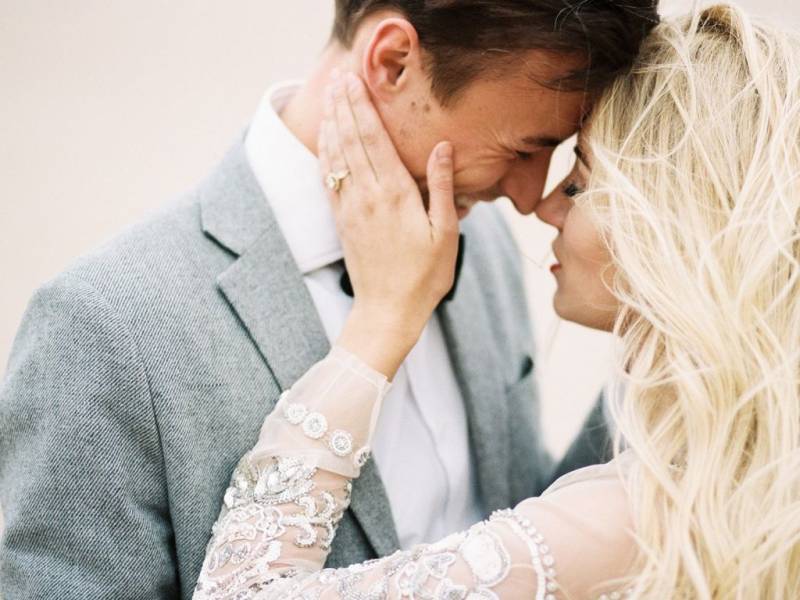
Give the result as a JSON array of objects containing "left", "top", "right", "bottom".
[{"left": 195, "top": 4, "right": 800, "bottom": 600}]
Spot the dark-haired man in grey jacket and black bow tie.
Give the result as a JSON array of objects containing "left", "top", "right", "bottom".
[{"left": 0, "top": 0, "right": 657, "bottom": 600}]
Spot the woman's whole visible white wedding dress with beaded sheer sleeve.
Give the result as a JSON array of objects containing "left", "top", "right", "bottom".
[{"left": 194, "top": 348, "right": 635, "bottom": 600}]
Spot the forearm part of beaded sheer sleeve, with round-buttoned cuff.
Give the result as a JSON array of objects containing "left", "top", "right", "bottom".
[{"left": 195, "top": 348, "right": 389, "bottom": 600}]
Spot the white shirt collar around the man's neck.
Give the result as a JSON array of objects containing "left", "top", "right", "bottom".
[{"left": 245, "top": 81, "right": 343, "bottom": 274}]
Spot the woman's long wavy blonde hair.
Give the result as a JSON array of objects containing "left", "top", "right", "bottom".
[{"left": 580, "top": 4, "right": 800, "bottom": 600}]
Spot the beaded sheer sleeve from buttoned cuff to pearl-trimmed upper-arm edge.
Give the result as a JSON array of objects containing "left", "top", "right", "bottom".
[{"left": 194, "top": 348, "right": 608, "bottom": 600}]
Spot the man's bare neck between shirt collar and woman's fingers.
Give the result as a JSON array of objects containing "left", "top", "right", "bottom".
[{"left": 280, "top": 46, "right": 348, "bottom": 155}]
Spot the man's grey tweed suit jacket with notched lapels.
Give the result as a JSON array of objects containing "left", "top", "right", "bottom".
[{"left": 0, "top": 137, "right": 608, "bottom": 600}]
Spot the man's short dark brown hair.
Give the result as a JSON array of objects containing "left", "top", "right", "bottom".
[{"left": 333, "top": 0, "right": 659, "bottom": 103}]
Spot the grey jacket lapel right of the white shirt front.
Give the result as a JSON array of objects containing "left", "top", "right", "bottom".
[{"left": 439, "top": 253, "right": 511, "bottom": 512}]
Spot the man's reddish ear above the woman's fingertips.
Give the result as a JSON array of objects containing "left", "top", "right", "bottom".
[{"left": 362, "top": 18, "right": 422, "bottom": 101}]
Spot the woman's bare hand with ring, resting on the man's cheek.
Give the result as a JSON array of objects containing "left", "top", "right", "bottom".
[{"left": 319, "top": 73, "right": 458, "bottom": 378}]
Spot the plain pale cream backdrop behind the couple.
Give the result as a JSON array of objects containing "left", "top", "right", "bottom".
[{"left": 0, "top": 0, "right": 800, "bottom": 540}]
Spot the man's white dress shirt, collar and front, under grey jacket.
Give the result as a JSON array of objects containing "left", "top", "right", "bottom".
[{"left": 245, "top": 82, "right": 483, "bottom": 548}]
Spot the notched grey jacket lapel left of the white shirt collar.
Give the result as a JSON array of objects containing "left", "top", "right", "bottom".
[{"left": 201, "top": 143, "right": 399, "bottom": 555}]
